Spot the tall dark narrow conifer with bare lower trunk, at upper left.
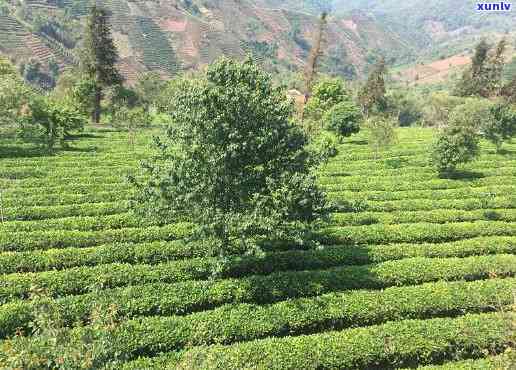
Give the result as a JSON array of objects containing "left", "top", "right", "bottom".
[{"left": 81, "top": 5, "right": 122, "bottom": 123}]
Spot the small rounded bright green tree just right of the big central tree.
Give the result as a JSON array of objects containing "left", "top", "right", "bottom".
[{"left": 323, "top": 100, "right": 362, "bottom": 137}]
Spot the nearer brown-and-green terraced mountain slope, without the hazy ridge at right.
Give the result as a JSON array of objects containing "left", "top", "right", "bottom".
[{"left": 0, "top": 0, "right": 412, "bottom": 80}]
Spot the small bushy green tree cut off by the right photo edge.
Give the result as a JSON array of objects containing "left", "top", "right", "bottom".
[{"left": 481, "top": 103, "right": 516, "bottom": 151}]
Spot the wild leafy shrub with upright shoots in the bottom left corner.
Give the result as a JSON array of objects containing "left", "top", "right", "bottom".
[{"left": 0, "top": 291, "right": 124, "bottom": 370}]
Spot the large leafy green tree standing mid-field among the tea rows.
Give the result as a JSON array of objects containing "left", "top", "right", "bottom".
[{"left": 132, "top": 59, "right": 328, "bottom": 254}]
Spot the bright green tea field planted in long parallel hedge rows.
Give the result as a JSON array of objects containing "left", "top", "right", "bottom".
[{"left": 0, "top": 128, "right": 516, "bottom": 369}]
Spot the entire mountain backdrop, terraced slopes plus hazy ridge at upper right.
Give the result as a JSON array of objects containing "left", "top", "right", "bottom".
[{"left": 0, "top": 0, "right": 516, "bottom": 85}]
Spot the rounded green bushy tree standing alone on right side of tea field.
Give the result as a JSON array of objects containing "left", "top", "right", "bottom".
[{"left": 432, "top": 123, "right": 480, "bottom": 174}]
